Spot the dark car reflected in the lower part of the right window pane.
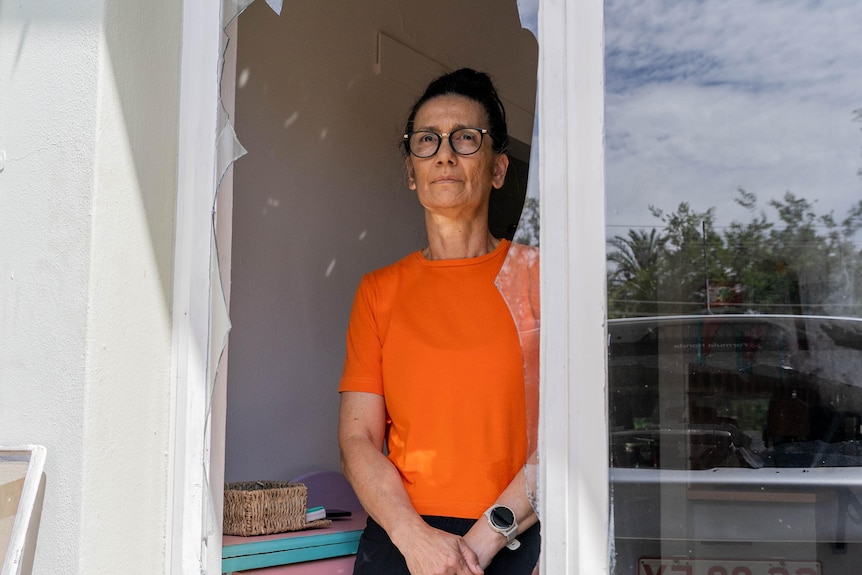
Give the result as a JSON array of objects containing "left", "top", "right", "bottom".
[{"left": 608, "top": 315, "right": 862, "bottom": 575}]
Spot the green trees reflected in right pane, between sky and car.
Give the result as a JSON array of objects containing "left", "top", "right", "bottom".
[{"left": 607, "top": 189, "right": 862, "bottom": 317}]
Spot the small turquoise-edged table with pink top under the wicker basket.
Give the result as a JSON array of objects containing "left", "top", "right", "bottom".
[{"left": 222, "top": 511, "right": 368, "bottom": 575}]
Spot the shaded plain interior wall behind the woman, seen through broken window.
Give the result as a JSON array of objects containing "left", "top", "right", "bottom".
[{"left": 225, "top": 0, "right": 538, "bottom": 481}]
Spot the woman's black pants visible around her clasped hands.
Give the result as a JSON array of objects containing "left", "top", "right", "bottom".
[{"left": 353, "top": 515, "right": 541, "bottom": 575}]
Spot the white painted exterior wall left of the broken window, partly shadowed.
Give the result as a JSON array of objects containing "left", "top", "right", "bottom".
[{"left": 0, "top": 0, "right": 181, "bottom": 575}]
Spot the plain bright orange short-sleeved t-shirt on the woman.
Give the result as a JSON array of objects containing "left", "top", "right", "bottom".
[{"left": 339, "top": 240, "right": 527, "bottom": 519}]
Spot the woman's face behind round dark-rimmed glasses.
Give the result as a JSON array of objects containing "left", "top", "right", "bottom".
[{"left": 407, "top": 95, "right": 509, "bottom": 216}]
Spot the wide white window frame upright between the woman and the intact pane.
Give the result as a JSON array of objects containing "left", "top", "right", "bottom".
[{"left": 538, "top": 0, "right": 610, "bottom": 575}]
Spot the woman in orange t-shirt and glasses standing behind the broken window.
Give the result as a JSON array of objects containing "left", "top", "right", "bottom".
[{"left": 338, "top": 69, "right": 540, "bottom": 575}]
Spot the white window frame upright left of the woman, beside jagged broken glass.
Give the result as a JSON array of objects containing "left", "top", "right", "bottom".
[{"left": 165, "top": 0, "right": 224, "bottom": 575}]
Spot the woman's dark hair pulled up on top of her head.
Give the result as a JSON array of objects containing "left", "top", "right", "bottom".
[{"left": 404, "top": 68, "right": 509, "bottom": 154}]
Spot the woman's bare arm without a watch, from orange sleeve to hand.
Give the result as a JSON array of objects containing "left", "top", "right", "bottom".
[{"left": 338, "top": 392, "right": 486, "bottom": 575}]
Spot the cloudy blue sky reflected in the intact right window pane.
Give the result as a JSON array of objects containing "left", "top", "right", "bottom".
[{"left": 608, "top": 0, "right": 862, "bottom": 235}]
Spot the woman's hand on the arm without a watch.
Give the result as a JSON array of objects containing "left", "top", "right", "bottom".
[{"left": 393, "top": 524, "right": 484, "bottom": 575}]
